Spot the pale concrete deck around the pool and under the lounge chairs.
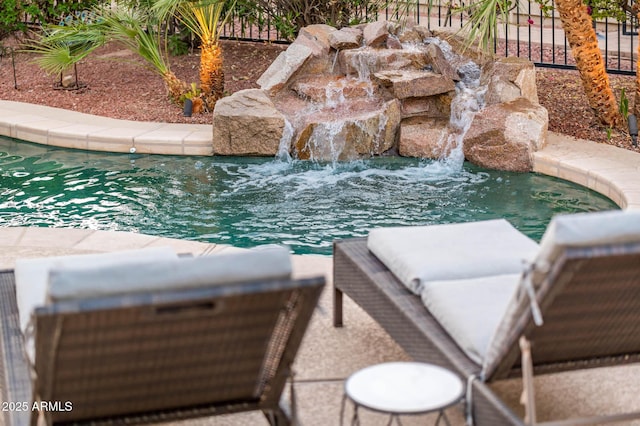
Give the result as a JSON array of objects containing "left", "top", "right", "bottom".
[{"left": 0, "top": 101, "right": 640, "bottom": 426}]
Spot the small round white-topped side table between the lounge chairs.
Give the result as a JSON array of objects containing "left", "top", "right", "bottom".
[{"left": 340, "top": 362, "right": 464, "bottom": 426}]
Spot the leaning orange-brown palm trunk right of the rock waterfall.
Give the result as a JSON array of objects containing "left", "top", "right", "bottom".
[{"left": 556, "top": 0, "right": 622, "bottom": 127}]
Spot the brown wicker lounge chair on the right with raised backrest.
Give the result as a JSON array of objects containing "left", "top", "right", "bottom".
[{"left": 333, "top": 211, "right": 640, "bottom": 426}]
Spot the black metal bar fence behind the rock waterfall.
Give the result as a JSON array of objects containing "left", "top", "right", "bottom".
[{"left": 223, "top": 0, "right": 638, "bottom": 75}]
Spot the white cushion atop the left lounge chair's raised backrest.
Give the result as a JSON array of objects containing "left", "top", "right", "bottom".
[{"left": 48, "top": 246, "right": 292, "bottom": 302}]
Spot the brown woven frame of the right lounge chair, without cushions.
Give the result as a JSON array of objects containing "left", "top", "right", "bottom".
[{"left": 333, "top": 238, "right": 640, "bottom": 426}]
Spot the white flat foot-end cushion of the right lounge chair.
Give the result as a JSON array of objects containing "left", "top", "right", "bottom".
[{"left": 367, "top": 219, "right": 538, "bottom": 294}]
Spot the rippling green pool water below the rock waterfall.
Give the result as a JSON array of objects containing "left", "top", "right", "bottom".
[{"left": 0, "top": 138, "right": 617, "bottom": 254}]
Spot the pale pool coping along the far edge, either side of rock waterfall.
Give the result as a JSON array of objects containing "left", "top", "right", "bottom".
[{"left": 0, "top": 100, "right": 640, "bottom": 209}]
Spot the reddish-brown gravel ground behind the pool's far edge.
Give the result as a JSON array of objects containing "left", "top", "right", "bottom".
[{"left": 0, "top": 35, "right": 638, "bottom": 151}]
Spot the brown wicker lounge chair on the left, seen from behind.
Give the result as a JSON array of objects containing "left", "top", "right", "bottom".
[{"left": 0, "top": 249, "right": 324, "bottom": 426}]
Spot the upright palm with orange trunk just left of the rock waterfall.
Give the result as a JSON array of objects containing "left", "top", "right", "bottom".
[{"left": 153, "top": 0, "right": 235, "bottom": 111}]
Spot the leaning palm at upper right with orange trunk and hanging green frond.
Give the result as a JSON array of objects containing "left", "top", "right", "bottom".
[{"left": 464, "top": 0, "right": 623, "bottom": 127}]
